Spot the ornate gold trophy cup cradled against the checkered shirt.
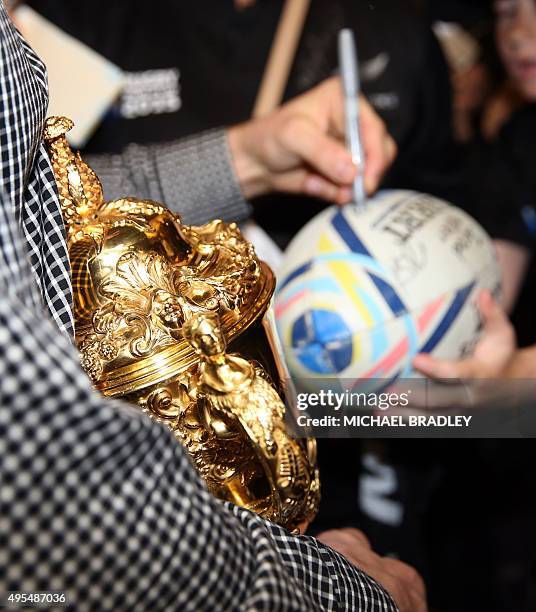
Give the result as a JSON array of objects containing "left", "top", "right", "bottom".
[{"left": 45, "top": 117, "right": 320, "bottom": 529}]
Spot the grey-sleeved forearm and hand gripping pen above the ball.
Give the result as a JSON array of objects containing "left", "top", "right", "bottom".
[{"left": 86, "top": 78, "right": 396, "bottom": 223}]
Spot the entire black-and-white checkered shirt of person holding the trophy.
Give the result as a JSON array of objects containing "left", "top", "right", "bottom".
[{"left": 0, "top": 3, "right": 396, "bottom": 612}]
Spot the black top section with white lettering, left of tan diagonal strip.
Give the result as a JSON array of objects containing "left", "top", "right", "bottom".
[{"left": 28, "top": 0, "right": 282, "bottom": 153}]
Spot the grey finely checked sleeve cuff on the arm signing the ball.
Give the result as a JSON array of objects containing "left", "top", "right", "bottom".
[{"left": 84, "top": 129, "right": 250, "bottom": 225}]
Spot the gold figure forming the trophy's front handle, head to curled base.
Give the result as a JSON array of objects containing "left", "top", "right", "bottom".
[{"left": 182, "top": 313, "right": 318, "bottom": 524}]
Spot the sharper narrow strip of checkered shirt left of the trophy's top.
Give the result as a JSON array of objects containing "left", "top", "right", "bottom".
[{"left": 0, "top": 2, "right": 73, "bottom": 334}]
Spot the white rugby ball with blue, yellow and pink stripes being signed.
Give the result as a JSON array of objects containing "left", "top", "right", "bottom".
[{"left": 275, "top": 190, "right": 500, "bottom": 386}]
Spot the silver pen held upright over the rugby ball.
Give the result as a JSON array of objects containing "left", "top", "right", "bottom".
[{"left": 339, "top": 28, "right": 366, "bottom": 208}]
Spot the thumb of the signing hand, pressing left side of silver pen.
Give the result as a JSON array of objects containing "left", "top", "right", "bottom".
[{"left": 279, "top": 115, "right": 357, "bottom": 186}]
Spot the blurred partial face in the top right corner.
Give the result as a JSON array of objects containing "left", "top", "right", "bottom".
[{"left": 494, "top": 0, "right": 536, "bottom": 101}]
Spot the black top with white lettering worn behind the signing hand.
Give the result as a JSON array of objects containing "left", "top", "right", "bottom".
[{"left": 29, "top": 0, "right": 457, "bottom": 246}]
